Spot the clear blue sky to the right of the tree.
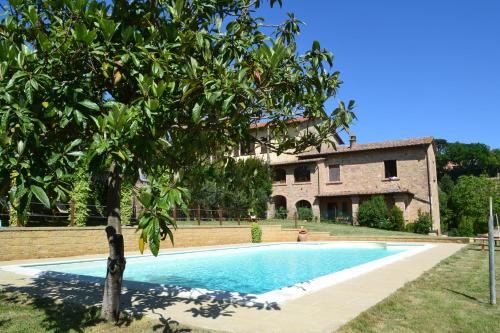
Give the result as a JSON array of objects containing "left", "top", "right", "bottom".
[{"left": 259, "top": 0, "right": 500, "bottom": 148}]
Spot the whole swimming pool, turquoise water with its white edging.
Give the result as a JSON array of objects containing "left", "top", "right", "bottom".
[{"left": 2, "top": 242, "right": 429, "bottom": 301}]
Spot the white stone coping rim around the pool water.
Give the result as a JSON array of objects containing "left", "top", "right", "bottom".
[{"left": 0, "top": 241, "right": 436, "bottom": 307}]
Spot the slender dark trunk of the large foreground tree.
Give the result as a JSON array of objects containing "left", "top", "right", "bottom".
[{"left": 101, "top": 162, "right": 125, "bottom": 321}]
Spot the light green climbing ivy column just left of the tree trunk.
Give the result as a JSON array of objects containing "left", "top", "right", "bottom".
[{"left": 69, "top": 168, "right": 90, "bottom": 226}]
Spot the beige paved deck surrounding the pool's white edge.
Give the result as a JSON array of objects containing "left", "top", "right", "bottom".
[{"left": 0, "top": 243, "right": 465, "bottom": 332}]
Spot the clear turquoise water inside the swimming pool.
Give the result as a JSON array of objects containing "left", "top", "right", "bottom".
[{"left": 30, "top": 244, "right": 404, "bottom": 294}]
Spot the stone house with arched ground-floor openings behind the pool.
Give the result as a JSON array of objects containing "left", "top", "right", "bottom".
[{"left": 237, "top": 119, "right": 440, "bottom": 231}]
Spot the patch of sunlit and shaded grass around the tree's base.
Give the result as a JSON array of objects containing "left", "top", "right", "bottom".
[{"left": 0, "top": 292, "right": 210, "bottom": 333}]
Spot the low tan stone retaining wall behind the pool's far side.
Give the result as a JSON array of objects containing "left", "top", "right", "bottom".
[{"left": 0, "top": 225, "right": 308, "bottom": 261}]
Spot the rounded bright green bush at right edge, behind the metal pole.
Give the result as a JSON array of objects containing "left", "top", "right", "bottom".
[{"left": 450, "top": 176, "right": 500, "bottom": 233}]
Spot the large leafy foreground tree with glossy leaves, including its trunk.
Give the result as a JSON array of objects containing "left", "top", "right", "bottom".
[{"left": 0, "top": 0, "right": 354, "bottom": 320}]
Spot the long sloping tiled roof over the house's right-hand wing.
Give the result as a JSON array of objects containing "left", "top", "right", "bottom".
[{"left": 299, "top": 137, "right": 433, "bottom": 158}]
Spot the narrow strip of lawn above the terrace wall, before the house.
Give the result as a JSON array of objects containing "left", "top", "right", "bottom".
[{"left": 173, "top": 219, "right": 426, "bottom": 237}]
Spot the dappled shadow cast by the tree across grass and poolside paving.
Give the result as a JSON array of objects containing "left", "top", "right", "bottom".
[{"left": 0, "top": 272, "right": 281, "bottom": 332}]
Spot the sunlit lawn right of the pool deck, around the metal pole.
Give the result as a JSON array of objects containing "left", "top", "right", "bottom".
[{"left": 338, "top": 245, "right": 500, "bottom": 333}]
